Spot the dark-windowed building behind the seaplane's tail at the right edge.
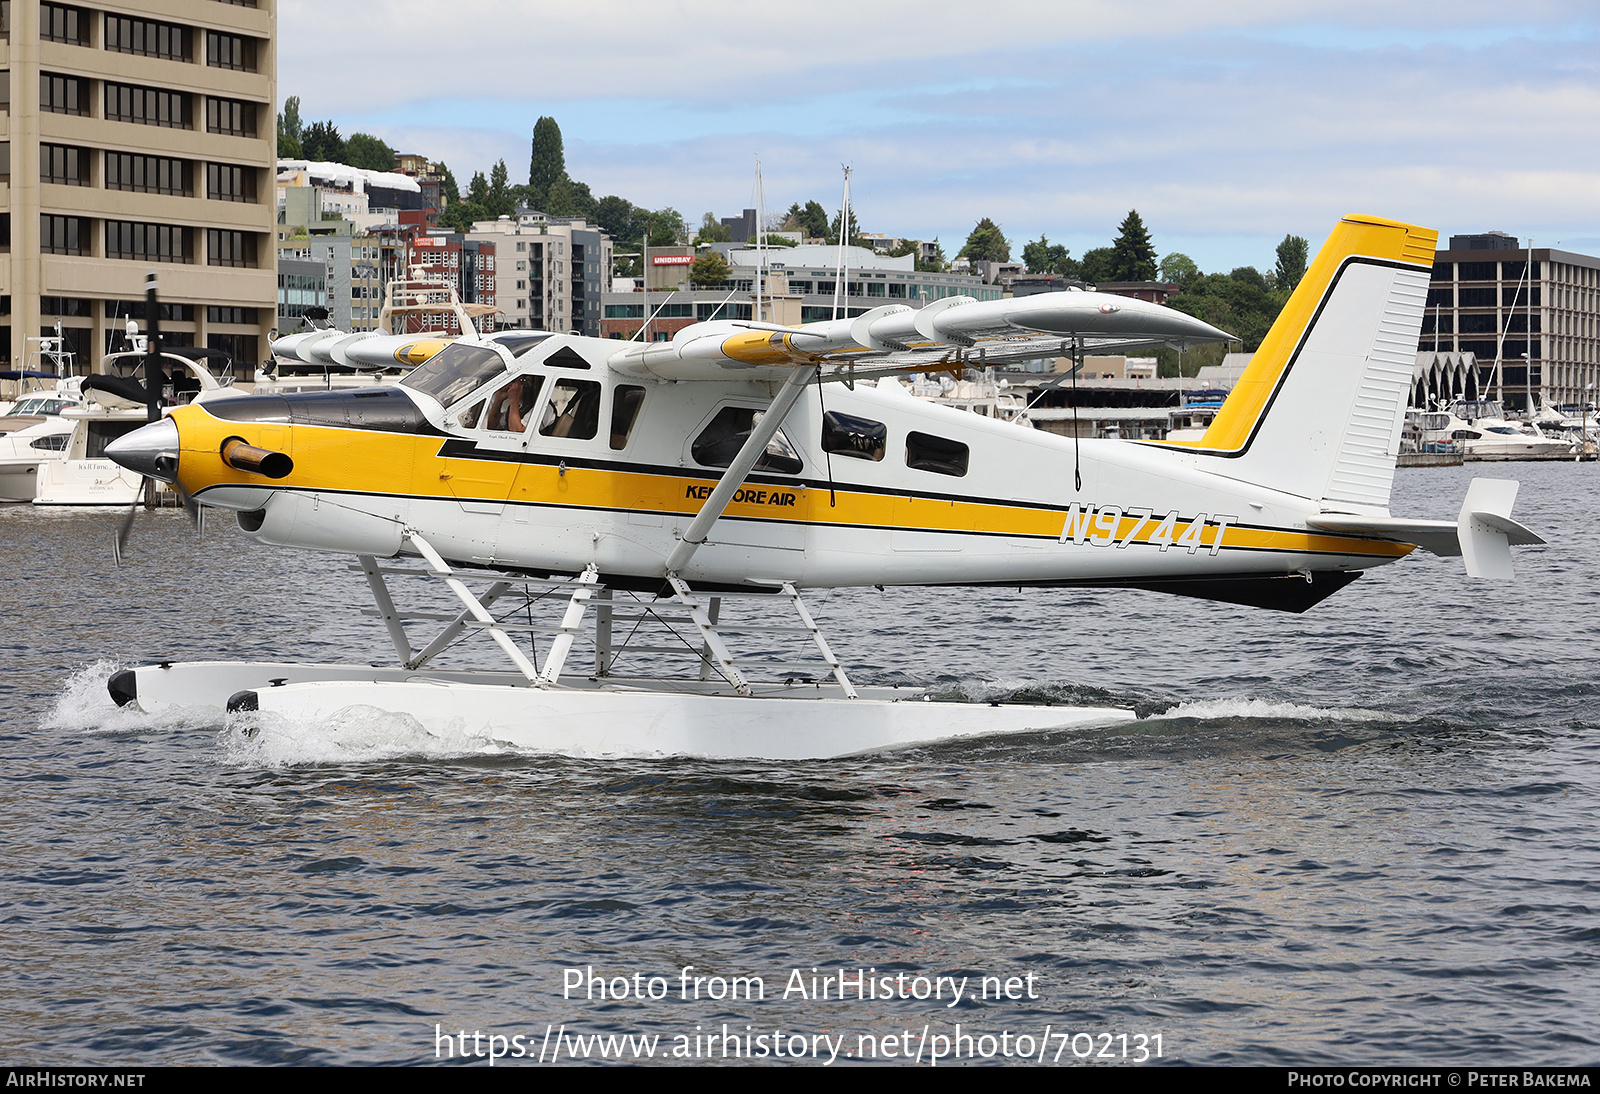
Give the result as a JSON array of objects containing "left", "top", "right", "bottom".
[{"left": 1418, "top": 232, "right": 1600, "bottom": 409}]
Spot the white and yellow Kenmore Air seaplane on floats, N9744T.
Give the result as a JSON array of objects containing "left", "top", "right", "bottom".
[{"left": 107, "top": 216, "right": 1542, "bottom": 758}]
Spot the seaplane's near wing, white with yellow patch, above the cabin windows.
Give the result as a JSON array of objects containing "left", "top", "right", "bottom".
[{"left": 610, "top": 291, "right": 1232, "bottom": 381}]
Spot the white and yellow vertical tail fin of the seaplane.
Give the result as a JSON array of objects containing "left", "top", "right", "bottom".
[{"left": 1186, "top": 216, "right": 1438, "bottom": 509}]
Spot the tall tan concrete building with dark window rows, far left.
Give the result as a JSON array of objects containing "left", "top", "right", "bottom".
[{"left": 0, "top": 0, "right": 277, "bottom": 374}]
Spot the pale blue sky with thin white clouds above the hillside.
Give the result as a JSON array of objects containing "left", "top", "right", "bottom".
[{"left": 278, "top": 0, "right": 1600, "bottom": 272}]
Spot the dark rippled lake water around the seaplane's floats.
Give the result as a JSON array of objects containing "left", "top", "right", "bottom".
[{"left": 0, "top": 464, "right": 1600, "bottom": 1065}]
